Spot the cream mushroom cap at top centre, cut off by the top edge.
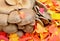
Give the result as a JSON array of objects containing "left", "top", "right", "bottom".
[{"left": 17, "top": 0, "right": 35, "bottom": 9}]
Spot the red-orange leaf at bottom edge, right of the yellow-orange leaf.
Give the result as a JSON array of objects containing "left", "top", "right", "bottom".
[{"left": 19, "top": 33, "right": 40, "bottom": 41}]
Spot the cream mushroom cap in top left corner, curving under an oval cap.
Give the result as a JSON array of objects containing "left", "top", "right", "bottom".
[{"left": 0, "top": 0, "right": 16, "bottom": 14}]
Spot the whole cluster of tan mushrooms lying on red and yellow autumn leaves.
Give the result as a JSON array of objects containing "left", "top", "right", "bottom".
[{"left": 0, "top": 0, "right": 51, "bottom": 36}]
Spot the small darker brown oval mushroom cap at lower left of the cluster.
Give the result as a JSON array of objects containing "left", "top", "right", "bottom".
[{"left": 3, "top": 24, "right": 17, "bottom": 34}]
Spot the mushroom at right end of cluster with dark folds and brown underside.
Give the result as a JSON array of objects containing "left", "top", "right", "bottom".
[{"left": 34, "top": 4, "right": 51, "bottom": 26}]
